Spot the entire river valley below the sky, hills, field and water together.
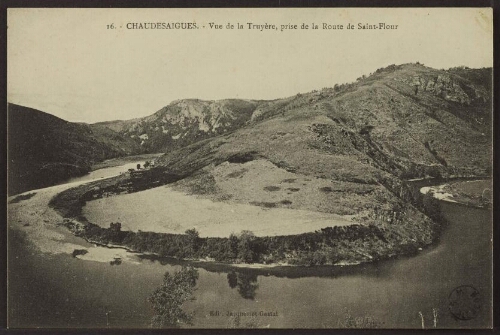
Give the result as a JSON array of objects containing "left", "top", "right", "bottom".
[{"left": 8, "top": 63, "right": 492, "bottom": 328}]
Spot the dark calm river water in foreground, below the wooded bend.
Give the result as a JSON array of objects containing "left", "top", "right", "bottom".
[{"left": 8, "top": 165, "right": 492, "bottom": 328}]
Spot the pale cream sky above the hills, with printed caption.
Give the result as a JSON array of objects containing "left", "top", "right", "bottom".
[{"left": 7, "top": 8, "right": 493, "bottom": 123}]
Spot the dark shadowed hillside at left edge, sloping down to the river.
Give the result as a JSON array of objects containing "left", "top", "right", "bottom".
[{"left": 8, "top": 104, "right": 141, "bottom": 194}]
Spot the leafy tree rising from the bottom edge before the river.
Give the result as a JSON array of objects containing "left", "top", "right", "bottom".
[{"left": 148, "top": 266, "right": 199, "bottom": 328}]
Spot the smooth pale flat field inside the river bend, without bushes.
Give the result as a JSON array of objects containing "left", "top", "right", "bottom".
[{"left": 82, "top": 187, "right": 353, "bottom": 237}]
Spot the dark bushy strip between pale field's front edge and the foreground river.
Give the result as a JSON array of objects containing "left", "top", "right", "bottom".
[{"left": 62, "top": 189, "right": 441, "bottom": 266}]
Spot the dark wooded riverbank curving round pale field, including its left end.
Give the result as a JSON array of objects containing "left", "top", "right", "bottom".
[{"left": 50, "top": 163, "right": 441, "bottom": 266}]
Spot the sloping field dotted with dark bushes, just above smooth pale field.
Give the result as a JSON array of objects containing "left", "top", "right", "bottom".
[{"left": 173, "top": 159, "right": 381, "bottom": 215}]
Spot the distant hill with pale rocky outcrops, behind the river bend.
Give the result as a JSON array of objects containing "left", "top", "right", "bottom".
[{"left": 93, "top": 99, "right": 316, "bottom": 153}]
